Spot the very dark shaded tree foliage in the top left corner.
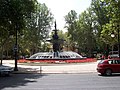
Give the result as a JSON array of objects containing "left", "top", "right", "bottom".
[{"left": 0, "top": 0, "right": 36, "bottom": 62}]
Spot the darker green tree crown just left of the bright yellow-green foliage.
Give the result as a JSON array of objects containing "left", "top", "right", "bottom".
[{"left": 91, "top": 0, "right": 109, "bottom": 32}]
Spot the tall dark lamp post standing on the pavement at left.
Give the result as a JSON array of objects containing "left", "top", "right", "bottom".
[{"left": 14, "top": 25, "right": 18, "bottom": 71}]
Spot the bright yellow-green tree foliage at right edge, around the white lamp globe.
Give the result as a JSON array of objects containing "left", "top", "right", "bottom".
[{"left": 101, "top": 0, "right": 120, "bottom": 50}]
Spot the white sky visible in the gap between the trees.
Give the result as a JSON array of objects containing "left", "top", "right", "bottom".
[{"left": 38, "top": 0, "right": 91, "bottom": 30}]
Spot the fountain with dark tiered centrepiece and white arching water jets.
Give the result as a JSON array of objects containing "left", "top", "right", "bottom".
[{"left": 27, "top": 22, "right": 83, "bottom": 60}]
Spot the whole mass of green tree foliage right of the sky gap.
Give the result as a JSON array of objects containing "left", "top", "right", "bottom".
[{"left": 65, "top": 0, "right": 120, "bottom": 54}]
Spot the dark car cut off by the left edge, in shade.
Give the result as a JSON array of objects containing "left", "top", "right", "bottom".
[{"left": 0, "top": 65, "right": 13, "bottom": 76}]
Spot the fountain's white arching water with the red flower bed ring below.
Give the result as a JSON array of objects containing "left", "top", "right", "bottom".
[{"left": 18, "top": 51, "right": 96, "bottom": 63}]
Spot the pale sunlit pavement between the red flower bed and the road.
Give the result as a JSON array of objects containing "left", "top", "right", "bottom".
[{"left": 3, "top": 60, "right": 98, "bottom": 74}]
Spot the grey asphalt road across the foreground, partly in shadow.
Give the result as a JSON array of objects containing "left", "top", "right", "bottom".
[{"left": 0, "top": 73, "right": 120, "bottom": 90}]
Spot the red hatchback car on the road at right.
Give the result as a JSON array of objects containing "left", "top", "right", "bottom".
[{"left": 97, "top": 58, "right": 120, "bottom": 76}]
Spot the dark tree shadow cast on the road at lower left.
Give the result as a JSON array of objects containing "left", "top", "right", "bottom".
[{"left": 0, "top": 68, "right": 46, "bottom": 90}]
